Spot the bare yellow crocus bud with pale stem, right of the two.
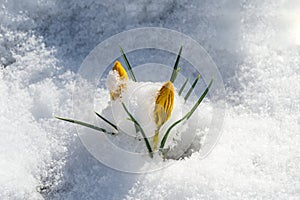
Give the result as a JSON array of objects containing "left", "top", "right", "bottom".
[{"left": 153, "top": 81, "right": 174, "bottom": 149}]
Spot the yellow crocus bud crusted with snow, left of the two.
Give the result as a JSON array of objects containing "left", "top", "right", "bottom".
[{"left": 110, "top": 61, "right": 128, "bottom": 100}]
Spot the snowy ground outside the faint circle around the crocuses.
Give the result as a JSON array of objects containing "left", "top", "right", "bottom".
[{"left": 0, "top": 0, "right": 300, "bottom": 199}]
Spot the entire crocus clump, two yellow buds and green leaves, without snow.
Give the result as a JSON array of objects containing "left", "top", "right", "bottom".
[{"left": 56, "top": 47, "right": 213, "bottom": 158}]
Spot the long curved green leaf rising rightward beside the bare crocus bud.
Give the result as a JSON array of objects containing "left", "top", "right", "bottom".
[{"left": 160, "top": 77, "right": 214, "bottom": 150}]
